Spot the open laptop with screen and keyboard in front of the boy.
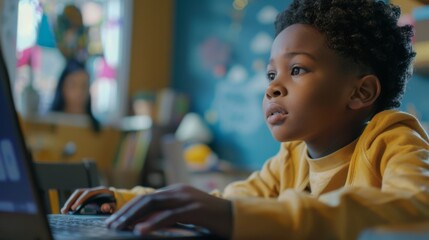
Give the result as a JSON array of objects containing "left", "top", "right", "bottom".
[{"left": 0, "top": 47, "right": 213, "bottom": 239}]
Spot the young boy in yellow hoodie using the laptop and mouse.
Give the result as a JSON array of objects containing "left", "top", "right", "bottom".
[{"left": 63, "top": 0, "right": 429, "bottom": 239}]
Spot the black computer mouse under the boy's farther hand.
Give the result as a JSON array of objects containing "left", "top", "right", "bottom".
[{"left": 69, "top": 193, "right": 115, "bottom": 215}]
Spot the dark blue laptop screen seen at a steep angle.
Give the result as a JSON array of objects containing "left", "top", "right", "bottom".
[{"left": 0, "top": 52, "right": 37, "bottom": 213}]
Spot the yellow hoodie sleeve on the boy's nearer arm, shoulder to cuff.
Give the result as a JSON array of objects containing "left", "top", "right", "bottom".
[{"left": 232, "top": 112, "right": 429, "bottom": 239}]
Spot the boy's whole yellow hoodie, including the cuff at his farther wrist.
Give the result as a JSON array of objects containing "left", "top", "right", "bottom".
[{"left": 108, "top": 110, "right": 429, "bottom": 239}]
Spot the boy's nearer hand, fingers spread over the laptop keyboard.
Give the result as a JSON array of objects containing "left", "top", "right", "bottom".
[{"left": 106, "top": 184, "right": 232, "bottom": 238}]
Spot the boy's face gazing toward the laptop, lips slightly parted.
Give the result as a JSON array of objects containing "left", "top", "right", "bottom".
[{"left": 263, "top": 24, "right": 358, "bottom": 143}]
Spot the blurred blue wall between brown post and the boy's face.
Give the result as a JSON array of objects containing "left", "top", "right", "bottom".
[{"left": 172, "top": 0, "right": 289, "bottom": 170}]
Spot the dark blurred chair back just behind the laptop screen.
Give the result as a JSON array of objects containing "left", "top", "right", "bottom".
[{"left": 34, "top": 160, "right": 100, "bottom": 213}]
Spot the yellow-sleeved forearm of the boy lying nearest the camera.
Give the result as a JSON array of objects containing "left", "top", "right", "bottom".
[{"left": 232, "top": 187, "right": 429, "bottom": 239}]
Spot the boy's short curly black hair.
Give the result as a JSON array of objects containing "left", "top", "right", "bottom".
[{"left": 275, "top": 0, "right": 415, "bottom": 112}]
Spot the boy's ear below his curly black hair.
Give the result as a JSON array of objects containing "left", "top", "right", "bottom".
[{"left": 348, "top": 75, "right": 381, "bottom": 110}]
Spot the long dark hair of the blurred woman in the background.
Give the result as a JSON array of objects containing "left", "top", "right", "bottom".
[{"left": 51, "top": 60, "right": 101, "bottom": 132}]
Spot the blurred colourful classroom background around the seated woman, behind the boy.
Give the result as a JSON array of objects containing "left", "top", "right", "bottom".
[{"left": 0, "top": 0, "right": 429, "bottom": 190}]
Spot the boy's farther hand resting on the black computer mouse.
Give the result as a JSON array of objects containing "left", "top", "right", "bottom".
[{"left": 61, "top": 187, "right": 116, "bottom": 214}]
